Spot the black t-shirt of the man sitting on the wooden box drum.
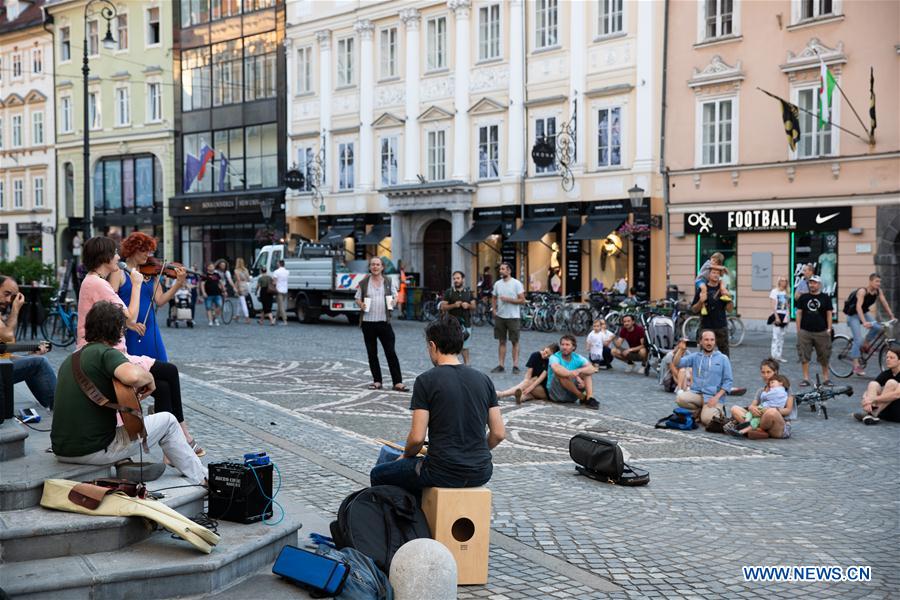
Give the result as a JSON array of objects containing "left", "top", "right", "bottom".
[{"left": 410, "top": 365, "right": 497, "bottom": 485}]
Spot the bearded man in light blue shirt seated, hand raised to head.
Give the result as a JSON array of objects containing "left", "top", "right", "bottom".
[{"left": 673, "top": 329, "right": 733, "bottom": 425}]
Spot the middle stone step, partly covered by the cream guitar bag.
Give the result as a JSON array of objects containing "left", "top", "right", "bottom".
[{"left": 0, "top": 474, "right": 206, "bottom": 564}]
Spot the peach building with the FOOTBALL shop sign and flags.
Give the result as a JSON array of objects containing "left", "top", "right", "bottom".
[{"left": 664, "top": 0, "right": 900, "bottom": 321}]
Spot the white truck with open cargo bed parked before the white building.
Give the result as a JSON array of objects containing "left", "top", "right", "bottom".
[{"left": 250, "top": 242, "right": 400, "bottom": 324}]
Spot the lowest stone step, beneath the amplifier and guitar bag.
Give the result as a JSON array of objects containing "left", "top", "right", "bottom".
[{"left": 0, "top": 502, "right": 304, "bottom": 600}]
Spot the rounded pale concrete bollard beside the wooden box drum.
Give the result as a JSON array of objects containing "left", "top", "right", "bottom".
[{"left": 390, "top": 538, "right": 456, "bottom": 600}]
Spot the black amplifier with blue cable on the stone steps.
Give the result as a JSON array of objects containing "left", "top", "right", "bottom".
[{"left": 207, "top": 463, "right": 273, "bottom": 523}]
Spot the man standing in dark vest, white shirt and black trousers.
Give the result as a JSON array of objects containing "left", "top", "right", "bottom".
[{"left": 356, "top": 256, "right": 409, "bottom": 392}]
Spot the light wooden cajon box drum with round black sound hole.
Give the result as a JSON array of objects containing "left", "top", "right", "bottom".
[{"left": 422, "top": 487, "right": 491, "bottom": 585}]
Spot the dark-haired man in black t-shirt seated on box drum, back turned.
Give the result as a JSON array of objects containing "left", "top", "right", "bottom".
[{"left": 369, "top": 316, "right": 506, "bottom": 494}]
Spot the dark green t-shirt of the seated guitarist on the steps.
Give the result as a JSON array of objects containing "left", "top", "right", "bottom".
[{"left": 50, "top": 342, "right": 128, "bottom": 456}]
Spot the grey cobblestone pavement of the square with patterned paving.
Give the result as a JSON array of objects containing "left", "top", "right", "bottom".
[{"left": 29, "top": 312, "right": 900, "bottom": 599}]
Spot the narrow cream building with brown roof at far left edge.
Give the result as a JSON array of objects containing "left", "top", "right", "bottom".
[{"left": 0, "top": 0, "right": 56, "bottom": 264}]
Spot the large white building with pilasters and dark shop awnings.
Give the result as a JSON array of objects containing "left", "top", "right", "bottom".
[{"left": 285, "top": 0, "right": 665, "bottom": 296}]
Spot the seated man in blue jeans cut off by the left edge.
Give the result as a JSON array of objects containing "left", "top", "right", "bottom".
[{"left": 0, "top": 275, "right": 56, "bottom": 410}]
